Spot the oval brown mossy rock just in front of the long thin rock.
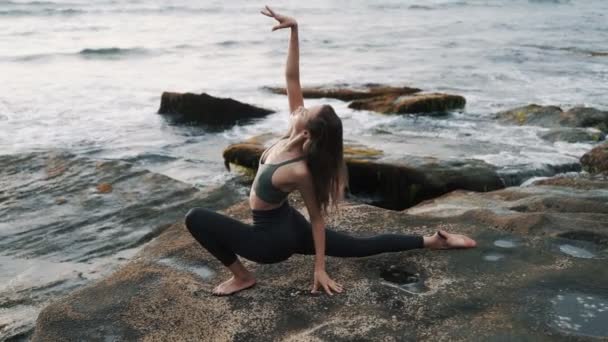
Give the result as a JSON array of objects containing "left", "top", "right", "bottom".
[{"left": 348, "top": 93, "right": 466, "bottom": 114}]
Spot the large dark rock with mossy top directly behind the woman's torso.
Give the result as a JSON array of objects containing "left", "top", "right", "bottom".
[{"left": 224, "top": 136, "right": 504, "bottom": 210}]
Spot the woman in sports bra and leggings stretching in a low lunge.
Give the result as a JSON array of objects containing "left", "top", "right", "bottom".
[{"left": 185, "top": 6, "right": 476, "bottom": 295}]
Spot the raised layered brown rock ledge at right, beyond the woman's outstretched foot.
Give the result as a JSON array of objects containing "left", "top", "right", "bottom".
[{"left": 407, "top": 176, "right": 608, "bottom": 238}]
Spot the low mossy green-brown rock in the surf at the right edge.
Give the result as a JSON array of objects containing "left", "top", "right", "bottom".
[{"left": 496, "top": 104, "right": 608, "bottom": 133}]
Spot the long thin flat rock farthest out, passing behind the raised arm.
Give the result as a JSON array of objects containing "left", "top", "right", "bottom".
[{"left": 264, "top": 83, "right": 420, "bottom": 101}]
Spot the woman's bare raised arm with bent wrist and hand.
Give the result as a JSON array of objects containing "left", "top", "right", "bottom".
[{"left": 261, "top": 6, "right": 304, "bottom": 113}]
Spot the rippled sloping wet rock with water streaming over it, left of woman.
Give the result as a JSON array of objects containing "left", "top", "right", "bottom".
[{"left": 0, "top": 150, "right": 238, "bottom": 341}]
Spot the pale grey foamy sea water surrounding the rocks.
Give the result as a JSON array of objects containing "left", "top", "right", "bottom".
[{"left": 0, "top": 0, "right": 608, "bottom": 340}]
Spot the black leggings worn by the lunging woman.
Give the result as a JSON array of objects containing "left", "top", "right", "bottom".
[{"left": 186, "top": 201, "right": 423, "bottom": 266}]
